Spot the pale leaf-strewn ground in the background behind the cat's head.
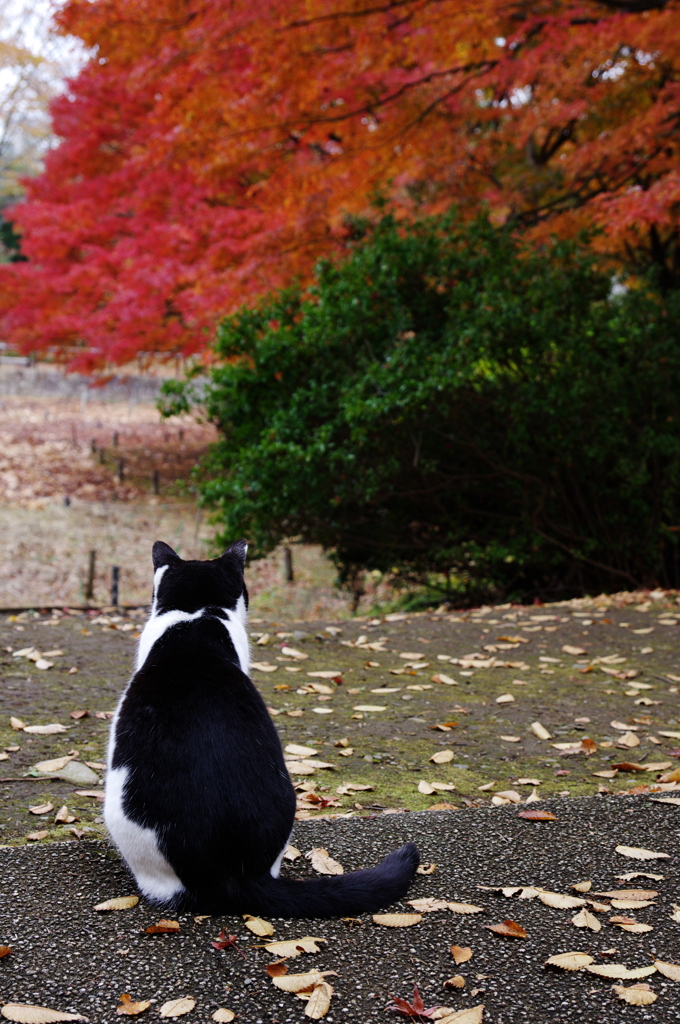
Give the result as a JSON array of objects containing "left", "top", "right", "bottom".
[{"left": 0, "top": 391, "right": 356, "bottom": 620}]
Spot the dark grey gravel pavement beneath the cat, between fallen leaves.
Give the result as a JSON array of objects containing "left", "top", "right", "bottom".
[{"left": 0, "top": 796, "right": 680, "bottom": 1024}]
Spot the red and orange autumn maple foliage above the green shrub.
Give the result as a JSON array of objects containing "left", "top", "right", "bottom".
[{"left": 0, "top": 0, "right": 680, "bottom": 371}]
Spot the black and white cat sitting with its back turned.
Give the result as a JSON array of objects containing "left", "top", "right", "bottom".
[{"left": 104, "top": 541, "right": 419, "bottom": 918}]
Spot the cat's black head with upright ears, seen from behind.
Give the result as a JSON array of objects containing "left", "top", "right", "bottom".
[{"left": 153, "top": 541, "right": 248, "bottom": 622}]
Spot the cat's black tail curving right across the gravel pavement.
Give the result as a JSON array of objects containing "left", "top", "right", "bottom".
[{"left": 178, "top": 843, "right": 420, "bottom": 918}]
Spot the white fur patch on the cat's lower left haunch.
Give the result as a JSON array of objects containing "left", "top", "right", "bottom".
[{"left": 103, "top": 768, "right": 184, "bottom": 902}]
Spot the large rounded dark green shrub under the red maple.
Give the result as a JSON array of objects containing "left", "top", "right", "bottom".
[{"left": 160, "top": 217, "right": 680, "bottom": 598}]
